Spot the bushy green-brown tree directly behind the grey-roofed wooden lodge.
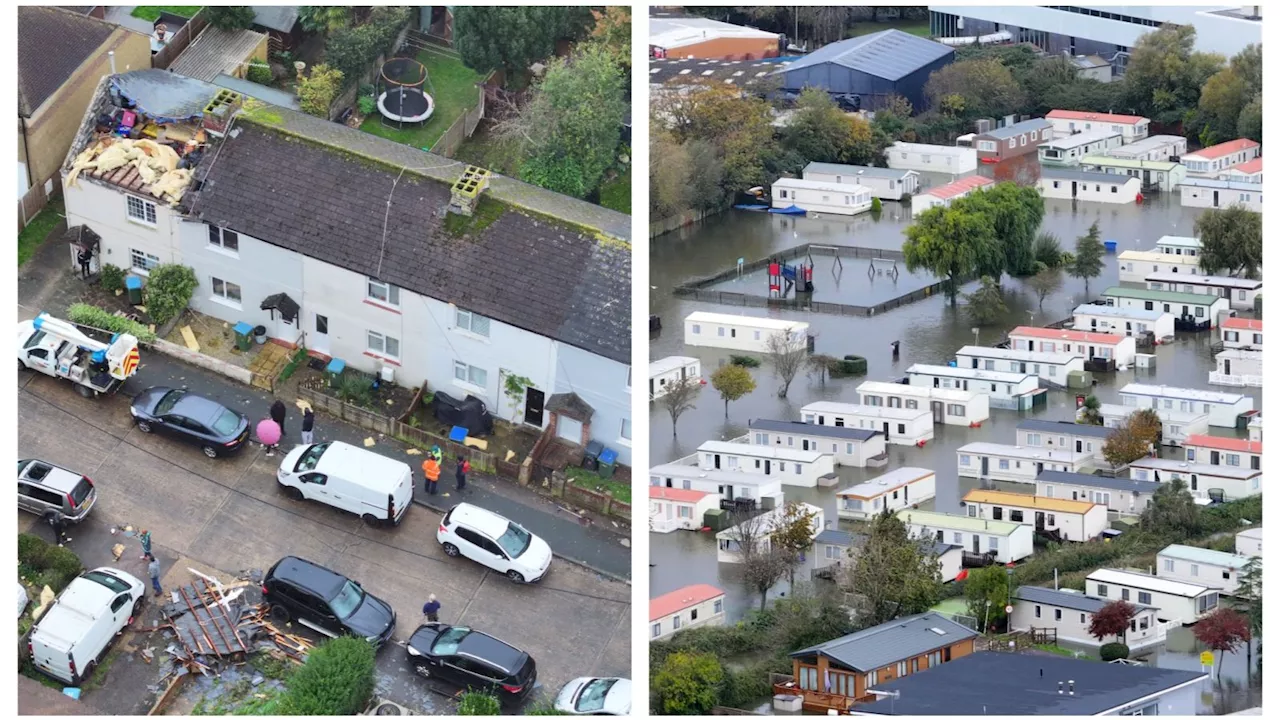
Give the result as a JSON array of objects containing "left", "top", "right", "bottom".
[{"left": 846, "top": 512, "right": 942, "bottom": 625}]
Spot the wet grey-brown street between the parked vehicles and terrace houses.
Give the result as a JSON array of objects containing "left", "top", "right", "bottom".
[{"left": 18, "top": 369, "right": 631, "bottom": 714}]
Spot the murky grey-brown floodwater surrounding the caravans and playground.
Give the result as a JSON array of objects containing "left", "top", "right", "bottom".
[{"left": 649, "top": 188, "right": 1262, "bottom": 702}]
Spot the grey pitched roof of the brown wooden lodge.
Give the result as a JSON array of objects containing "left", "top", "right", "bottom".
[{"left": 791, "top": 612, "right": 978, "bottom": 673}]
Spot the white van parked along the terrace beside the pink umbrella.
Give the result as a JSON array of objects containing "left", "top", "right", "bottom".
[{"left": 275, "top": 442, "right": 413, "bottom": 525}]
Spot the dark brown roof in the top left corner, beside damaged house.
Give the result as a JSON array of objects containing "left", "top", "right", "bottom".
[{"left": 18, "top": 5, "right": 116, "bottom": 118}]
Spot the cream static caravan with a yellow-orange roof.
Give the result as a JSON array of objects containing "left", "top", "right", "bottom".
[{"left": 961, "top": 489, "right": 1107, "bottom": 542}]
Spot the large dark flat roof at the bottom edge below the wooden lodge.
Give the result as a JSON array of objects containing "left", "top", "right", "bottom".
[{"left": 852, "top": 651, "right": 1207, "bottom": 716}]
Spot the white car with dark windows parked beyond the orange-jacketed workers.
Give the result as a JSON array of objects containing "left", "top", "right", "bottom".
[{"left": 435, "top": 502, "right": 552, "bottom": 583}]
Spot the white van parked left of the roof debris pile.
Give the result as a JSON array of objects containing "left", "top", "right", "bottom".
[{"left": 27, "top": 568, "right": 147, "bottom": 685}]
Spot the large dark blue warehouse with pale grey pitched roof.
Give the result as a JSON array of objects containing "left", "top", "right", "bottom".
[{"left": 780, "top": 29, "right": 955, "bottom": 113}]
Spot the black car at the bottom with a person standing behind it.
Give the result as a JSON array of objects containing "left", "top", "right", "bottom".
[{"left": 406, "top": 623, "right": 538, "bottom": 703}]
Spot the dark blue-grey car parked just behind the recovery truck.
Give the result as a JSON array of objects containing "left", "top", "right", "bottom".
[{"left": 129, "top": 387, "right": 248, "bottom": 457}]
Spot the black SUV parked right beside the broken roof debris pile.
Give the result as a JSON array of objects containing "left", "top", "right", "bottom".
[{"left": 262, "top": 556, "right": 396, "bottom": 648}]
